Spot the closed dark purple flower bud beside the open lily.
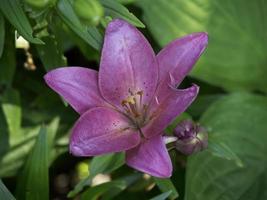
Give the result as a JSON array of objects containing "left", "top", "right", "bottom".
[{"left": 174, "top": 120, "right": 208, "bottom": 155}]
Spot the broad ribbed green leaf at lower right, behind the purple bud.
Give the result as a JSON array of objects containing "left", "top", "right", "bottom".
[{"left": 185, "top": 93, "right": 267, "bottom": 200}]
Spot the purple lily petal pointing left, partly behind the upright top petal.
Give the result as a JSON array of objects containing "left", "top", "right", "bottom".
[{"left": 44, "top": 67, "right": 107, "bottom": 114}]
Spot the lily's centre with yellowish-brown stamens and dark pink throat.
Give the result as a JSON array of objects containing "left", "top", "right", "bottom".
[{"left": 121, "top": 90, "right": 147, "bottom": 128}]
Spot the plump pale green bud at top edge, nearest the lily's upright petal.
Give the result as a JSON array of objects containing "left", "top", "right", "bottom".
[{"left": 74, "top": 0, "right": 104, "bottom": 25}]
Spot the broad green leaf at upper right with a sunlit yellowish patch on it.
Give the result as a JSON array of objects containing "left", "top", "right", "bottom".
[{"left": 136, "top": 0, "right": 267, "bottom": 92}]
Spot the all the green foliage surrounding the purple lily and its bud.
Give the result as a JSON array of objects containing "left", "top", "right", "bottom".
[{"left": 0, "top": 0, "right": 267, "bottom": 200}]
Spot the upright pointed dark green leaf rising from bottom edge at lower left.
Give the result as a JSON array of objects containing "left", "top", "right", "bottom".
[{"left": 17, "top": 127, "right": 49, "bottom": 200}]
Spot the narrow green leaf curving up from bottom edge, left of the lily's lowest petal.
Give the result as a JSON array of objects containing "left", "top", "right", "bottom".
[{"left": 81, "top": 180, "right": 127, "bottom": 200}]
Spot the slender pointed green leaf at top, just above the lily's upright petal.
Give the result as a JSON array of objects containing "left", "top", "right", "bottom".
[{"left": 100, "top": 0, "right": 145, "bottom": 28}]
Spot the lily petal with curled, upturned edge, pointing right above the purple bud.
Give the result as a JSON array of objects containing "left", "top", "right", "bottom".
[{"left": 142, "top": 85, "right": 199, "bottom": 138}]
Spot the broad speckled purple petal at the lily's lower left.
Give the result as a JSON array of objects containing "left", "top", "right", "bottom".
[{"left": 70, "top": 107, "right": 140, "bottom": 156}]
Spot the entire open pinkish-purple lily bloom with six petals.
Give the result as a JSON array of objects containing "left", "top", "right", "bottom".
[{"left": 45, "top": 19, "right": 208, "bottom": 177}]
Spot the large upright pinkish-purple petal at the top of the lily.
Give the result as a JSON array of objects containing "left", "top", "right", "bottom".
[{"left": 99, "top": 19, "right": 158, "bottom": 106}]
